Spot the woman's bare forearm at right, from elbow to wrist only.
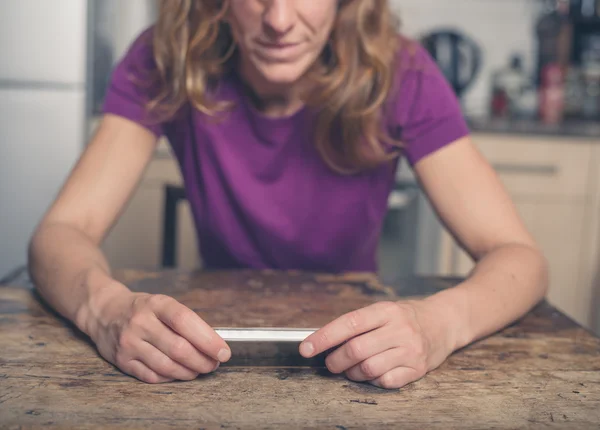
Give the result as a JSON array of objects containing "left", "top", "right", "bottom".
[{"left": 426, "top": 244, "right": 548, "bottom": 349}]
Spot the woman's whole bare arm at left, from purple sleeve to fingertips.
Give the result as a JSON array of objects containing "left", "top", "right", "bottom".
[{"left": 29, "top": 115, "right": 231, "bottom": 382}]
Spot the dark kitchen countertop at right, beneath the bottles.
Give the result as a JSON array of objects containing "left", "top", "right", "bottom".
[{"left": 467, "top": 118, "right": 600, "bottom": 142}]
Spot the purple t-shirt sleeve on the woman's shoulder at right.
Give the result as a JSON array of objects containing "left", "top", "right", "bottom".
[{"left": 388, "top": 42, "right": 469, "bottom": 166}]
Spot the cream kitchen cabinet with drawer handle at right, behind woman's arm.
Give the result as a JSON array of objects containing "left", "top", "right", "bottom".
[{"left": 439, "top": 133, "right": 600, "bottom": 327}]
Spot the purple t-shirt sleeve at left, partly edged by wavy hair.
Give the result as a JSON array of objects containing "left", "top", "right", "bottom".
[{"left": 103, "top": 27, "right": 163, "bottom": 137}]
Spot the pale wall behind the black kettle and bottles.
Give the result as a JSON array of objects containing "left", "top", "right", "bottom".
[{"left": 390, "top": 0, "right": 541, "bottom": 116}]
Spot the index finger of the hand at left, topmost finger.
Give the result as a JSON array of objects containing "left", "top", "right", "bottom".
[{"left": 152, "top": 295, "right": 231, "bottom": 362}]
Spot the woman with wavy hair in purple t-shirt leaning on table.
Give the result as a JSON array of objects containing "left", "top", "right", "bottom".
[{"left": 30, "top": 0, "right": 547, "bottom": 388}]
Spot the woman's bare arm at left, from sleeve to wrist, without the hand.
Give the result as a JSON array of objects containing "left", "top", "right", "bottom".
[{"left": 29, "top": 115, "right": 156, "bottom": 332}]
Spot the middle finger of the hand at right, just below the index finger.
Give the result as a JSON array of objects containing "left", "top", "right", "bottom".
[{"left": 325, "top": 327, "right": 400, "bottom": 376}]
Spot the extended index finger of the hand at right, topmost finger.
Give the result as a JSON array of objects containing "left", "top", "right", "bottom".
[{"left": 300, "top": 303, "right": 395, "bottom": 357}]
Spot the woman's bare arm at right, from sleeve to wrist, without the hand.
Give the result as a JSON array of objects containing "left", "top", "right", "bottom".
[{"left": 415, "top": 138, "right": 548, "bottom": 348}]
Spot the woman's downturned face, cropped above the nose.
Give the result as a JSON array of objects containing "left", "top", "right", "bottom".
[{"left": 228, "top": 0, "right": 338, "bottom": 85}]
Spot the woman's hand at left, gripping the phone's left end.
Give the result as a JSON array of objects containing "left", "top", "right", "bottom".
[{"left": 90, "top": 291, "right": 231, "bottom": 383}]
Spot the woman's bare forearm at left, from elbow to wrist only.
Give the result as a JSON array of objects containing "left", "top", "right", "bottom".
[{"left": 28, "top": 223, "right": 129, "bottom": 334}]
